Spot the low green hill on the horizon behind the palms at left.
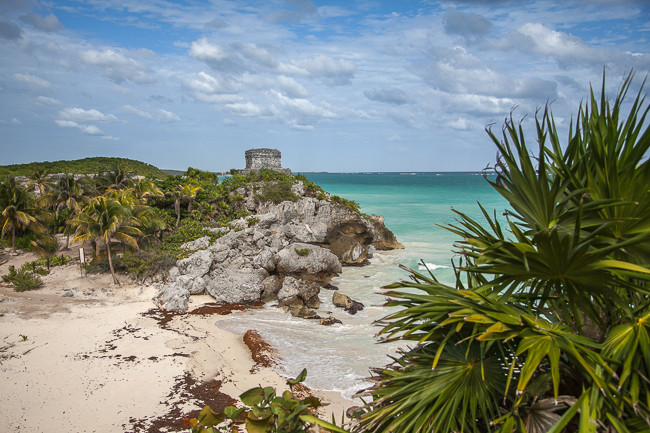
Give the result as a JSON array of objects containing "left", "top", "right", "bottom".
[{"left": 0, "top": 156, "right": 167, "bottom": 179}]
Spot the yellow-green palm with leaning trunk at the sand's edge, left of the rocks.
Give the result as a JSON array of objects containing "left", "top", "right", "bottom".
[{"left": 72, "top": 196, "right": 142, "bottom": 286}]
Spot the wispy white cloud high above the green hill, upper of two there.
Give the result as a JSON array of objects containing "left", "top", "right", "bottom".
[{"left": 79, "top": 49, "right": 156, "bottom": 84}]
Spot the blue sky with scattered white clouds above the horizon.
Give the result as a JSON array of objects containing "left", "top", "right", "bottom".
[{"left": 0, "top": 0, "right": 650, "bottom": 172}]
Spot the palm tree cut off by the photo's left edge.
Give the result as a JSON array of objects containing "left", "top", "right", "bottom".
[{"left": 0, "top": 176, "right": 45, "bottom": 254}]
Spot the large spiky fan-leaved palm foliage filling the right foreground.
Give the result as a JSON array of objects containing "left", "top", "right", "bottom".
[{"left": 359, "top": 71, "right": 650, "bottom": 433}]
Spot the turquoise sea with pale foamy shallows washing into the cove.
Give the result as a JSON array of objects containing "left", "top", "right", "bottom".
[{"left": 217, "top": 173, "right": 506, "bottom": 398}]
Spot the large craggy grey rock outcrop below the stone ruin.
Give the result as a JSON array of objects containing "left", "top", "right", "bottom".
[{"left": 154, "top": 177, "right": 404, "bottom": 312}]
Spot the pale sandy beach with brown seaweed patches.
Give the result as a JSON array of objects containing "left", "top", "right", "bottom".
[{"left": 0, "top": 243, "right": 353, "bottom": 433}]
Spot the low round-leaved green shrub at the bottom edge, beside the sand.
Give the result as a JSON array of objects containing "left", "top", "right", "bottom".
[{"left": 183, "top": 370, "right": 348, "bottom": 433}]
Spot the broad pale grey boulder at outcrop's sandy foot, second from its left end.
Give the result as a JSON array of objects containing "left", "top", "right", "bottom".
[{"left": 205, "top": 267, "right": 268, "bottom": 304}]
